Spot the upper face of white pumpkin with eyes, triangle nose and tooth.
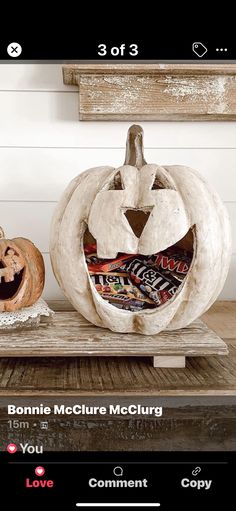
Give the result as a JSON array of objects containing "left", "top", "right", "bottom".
[{"left": 88, "top": 165, "right": 191, "bottom": 259}]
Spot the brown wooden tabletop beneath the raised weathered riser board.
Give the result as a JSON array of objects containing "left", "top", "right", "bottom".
[{"left": 0, "top": 344, "right": 236, "bottom": 399}]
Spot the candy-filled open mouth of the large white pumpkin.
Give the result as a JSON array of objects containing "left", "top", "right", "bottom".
[{"left": 84, "top": 227, "right": 195, "bottom": 312}]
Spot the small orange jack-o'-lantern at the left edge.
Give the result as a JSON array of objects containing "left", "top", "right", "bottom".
[{"left": 0, "top": 228, "right": 44, "bottom": 312}]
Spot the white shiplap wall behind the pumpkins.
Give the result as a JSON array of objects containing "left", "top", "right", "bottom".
[{"left": 0, "top": 63, "right": 236, "bottom": 300}]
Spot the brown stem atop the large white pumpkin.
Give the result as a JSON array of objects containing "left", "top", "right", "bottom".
[{"left": 124, "top": 124, "right": 147, "bottom": 169}]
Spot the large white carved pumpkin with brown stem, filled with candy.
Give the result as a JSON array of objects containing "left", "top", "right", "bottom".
[{"left": 50, "top": 125, "right": 231, "bottom": 334}]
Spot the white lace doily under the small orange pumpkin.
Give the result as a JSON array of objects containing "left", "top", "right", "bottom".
[{"left": 0, "top": 298, "right": 54, "bottom": 329}]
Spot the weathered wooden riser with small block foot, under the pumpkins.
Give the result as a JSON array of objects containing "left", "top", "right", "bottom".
[{"left": 0, "top": 311, "right": 228, "bottom": 367}]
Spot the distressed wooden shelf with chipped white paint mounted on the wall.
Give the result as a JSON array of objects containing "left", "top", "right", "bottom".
[{"left": 63, "top": 64, "right": 236, "bottom": 121}]
